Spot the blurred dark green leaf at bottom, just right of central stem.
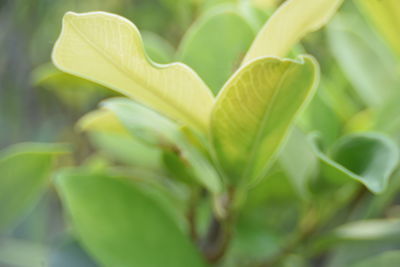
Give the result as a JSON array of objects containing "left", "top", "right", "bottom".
[{"left": 224, "top": 167, "right": 302, "bottom": 267}]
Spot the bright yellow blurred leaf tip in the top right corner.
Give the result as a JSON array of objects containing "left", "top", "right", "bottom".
[{"left": 355, "top": 0, "right": 400, "bottom": 56}]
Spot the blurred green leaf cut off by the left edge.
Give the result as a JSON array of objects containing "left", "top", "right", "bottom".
[{"left": 0, "top": 143, "right": 66, "bottom": 231}]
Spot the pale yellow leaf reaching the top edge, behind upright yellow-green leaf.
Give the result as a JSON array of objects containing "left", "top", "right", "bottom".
[{"left": 242, "top": 0, "right": 343, "bottom": 64}]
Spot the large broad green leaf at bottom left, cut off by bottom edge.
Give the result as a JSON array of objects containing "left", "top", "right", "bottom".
[{"left": 56, "top": 171, "right": 205, "bottom": 267}]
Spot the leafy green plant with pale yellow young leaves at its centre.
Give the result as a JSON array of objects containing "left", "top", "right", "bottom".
[{"left": 0, "top": 0, "right": 400, "bottom": 267}]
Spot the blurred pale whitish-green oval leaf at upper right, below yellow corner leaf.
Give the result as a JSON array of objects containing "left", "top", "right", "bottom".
[{"left": 327, "top": 13, "right": 400, "bottom": 106}]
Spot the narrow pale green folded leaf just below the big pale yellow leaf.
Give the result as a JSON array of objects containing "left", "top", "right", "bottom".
[{"left": 103, "top": 98, "right": 222, "bottom": 193}]
